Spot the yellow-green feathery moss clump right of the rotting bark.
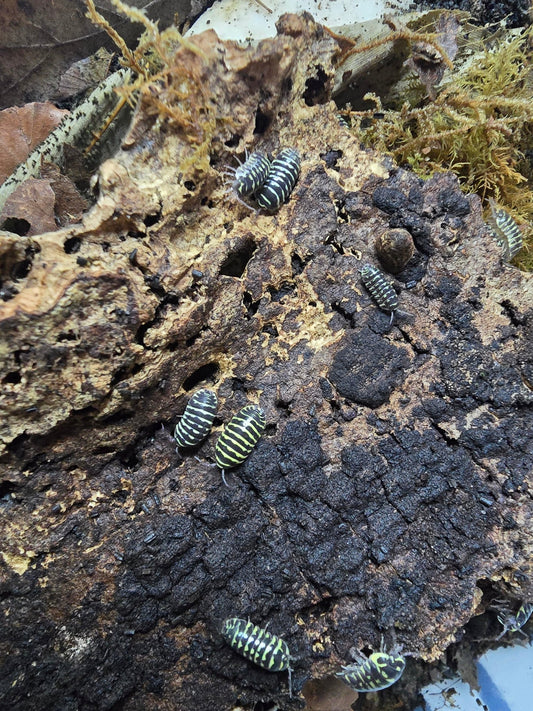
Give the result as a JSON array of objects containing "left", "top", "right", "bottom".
[{"left": 350, "top": 28, "right": 533, "bottom": 270}]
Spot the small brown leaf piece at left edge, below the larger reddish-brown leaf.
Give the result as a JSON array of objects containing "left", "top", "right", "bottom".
[{"left": 0, "top": 178, "right": 57, "bottom": 237}]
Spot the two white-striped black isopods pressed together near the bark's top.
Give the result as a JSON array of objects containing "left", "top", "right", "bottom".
[{"left": 223, "top": 148, "right": 300, "bottom": 212}]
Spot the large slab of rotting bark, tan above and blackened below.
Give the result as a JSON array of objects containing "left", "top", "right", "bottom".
[{"left": 0, "top": 16, "right": 533, "bottom": 711}]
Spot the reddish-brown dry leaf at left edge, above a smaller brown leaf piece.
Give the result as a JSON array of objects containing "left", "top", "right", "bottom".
[{"left": 0, "top": 103, "right": 68, "bottom": 183}]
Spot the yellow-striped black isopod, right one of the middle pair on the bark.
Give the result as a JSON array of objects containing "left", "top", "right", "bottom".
[{"left": 215, "top": 405, "right": 266, "bottom": 484}]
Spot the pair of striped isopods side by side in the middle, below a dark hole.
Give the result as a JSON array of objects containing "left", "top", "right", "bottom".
[{"left": 174, "top": 389, "right": 266, "bottom": 485}]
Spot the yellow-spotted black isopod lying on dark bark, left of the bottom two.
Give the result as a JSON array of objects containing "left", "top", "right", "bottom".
[{"left": 221, "top": 617, "right": 292, "bottom": 696}]
